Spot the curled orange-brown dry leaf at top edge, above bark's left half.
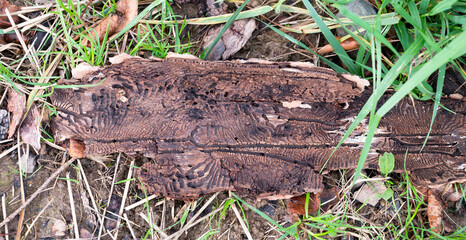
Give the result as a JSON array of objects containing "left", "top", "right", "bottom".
[{"left": 82, "top": 0, "right": 138, "bottom": 45}]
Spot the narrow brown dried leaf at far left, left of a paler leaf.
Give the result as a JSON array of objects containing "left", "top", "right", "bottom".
[{"left": 8, "top": 88, "right": 26, "bottom": 138}]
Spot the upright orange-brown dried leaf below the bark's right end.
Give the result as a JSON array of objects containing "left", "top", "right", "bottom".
[{"left": 427, "top": 190, "right": 444, "bottom": 234}]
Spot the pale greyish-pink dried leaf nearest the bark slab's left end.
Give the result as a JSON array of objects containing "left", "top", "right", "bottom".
[{"left": 19, "top": 104, "right": 41, "bottom": 151}]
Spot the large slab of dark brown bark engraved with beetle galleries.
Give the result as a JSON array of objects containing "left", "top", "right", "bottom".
[{"left": 52, "top": 55, "right": 466, "bottom": 199}]
